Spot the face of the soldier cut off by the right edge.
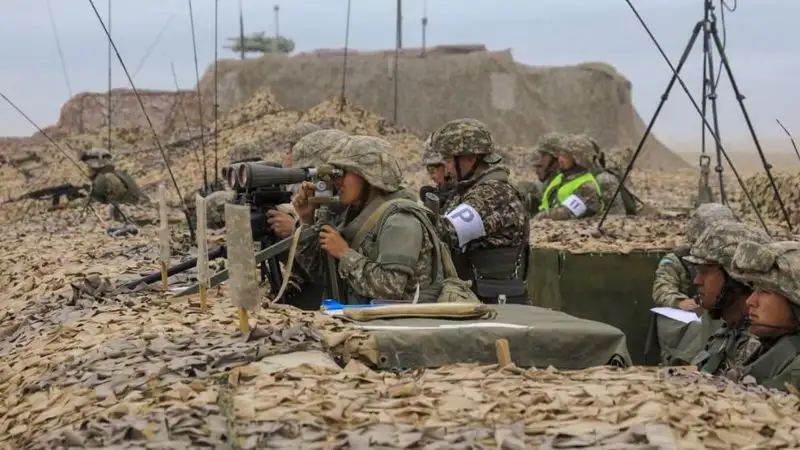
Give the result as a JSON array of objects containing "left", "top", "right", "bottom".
[{"left": 746, "top": 288, "right": 797, "bottom": 337}]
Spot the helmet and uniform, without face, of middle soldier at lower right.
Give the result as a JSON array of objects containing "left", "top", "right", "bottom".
[{"left": 683, "top": 222, "right": 771, "bottom": 375}]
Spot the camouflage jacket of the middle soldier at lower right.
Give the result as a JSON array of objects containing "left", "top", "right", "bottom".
[{"left": 692, "top": 321, "right": 761, "bottom": 375}]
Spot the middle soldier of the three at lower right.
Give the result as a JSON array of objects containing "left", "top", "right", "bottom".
[{"left": 683, "top": 222, "right": 771, "bottom": 375}]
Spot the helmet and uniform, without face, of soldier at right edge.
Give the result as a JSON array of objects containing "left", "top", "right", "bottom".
[{"left": 727, "top": 241, "right": 800, "bottom": 390}]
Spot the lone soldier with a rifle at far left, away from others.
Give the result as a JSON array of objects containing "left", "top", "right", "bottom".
[{"left": 80, "top": 148, "right": 150, "bottom": 220}]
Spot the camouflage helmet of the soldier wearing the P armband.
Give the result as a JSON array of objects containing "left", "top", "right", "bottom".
[{"left": 431, "top": 119, "right": 503, "bottom": 164}]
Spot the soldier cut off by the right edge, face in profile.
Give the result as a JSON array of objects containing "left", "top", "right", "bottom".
[{"left": 726, "top": 241, "right": 800, "bottom": 390}]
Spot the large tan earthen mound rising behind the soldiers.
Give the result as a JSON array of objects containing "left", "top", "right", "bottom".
[{"left": 201, "top": 51, "right": 687, "bottom": 170}]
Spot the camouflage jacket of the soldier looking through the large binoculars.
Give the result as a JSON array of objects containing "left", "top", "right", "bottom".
[{"left": 297, "top": 193, "right": 439, "bottom": 304}]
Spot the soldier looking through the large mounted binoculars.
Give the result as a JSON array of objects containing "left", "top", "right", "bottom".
[{"left": 292, "top": 136, "right": 443, "bottom": 304}]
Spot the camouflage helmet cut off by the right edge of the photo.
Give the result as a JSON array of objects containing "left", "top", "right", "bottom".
[{"left": 729, "top": 240, "right": 800, "bottom": 310}]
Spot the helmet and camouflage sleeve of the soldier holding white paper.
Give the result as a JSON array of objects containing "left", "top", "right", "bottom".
[{"left": 653, "top": 203, "right": 736, "bottom": 308}]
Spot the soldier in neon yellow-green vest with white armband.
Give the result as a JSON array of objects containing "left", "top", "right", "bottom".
[{"left": 534, "top": 135, "right": 603, "bottom": 220}]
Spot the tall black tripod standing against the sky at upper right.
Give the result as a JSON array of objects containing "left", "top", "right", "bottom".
[{"left": 597, "top": 0, "right": 792, "bottom": 230}]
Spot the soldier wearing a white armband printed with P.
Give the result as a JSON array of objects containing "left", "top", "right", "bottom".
[{"left": 431, "top": 119, "right": 530, "bottom": 303}]
